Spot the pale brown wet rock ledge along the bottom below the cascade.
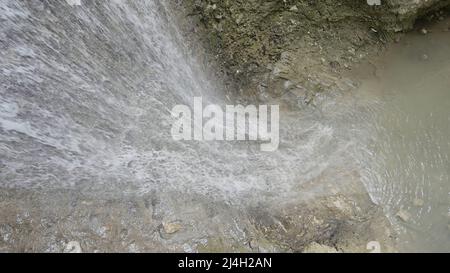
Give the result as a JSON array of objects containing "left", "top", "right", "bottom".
[{"left": 0, "top": 186, "right": 392, "bottom": 253}]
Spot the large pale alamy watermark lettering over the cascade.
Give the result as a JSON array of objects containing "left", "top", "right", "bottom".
[{"left": 171, "top": 97, "right": 280, "bottom": 152}]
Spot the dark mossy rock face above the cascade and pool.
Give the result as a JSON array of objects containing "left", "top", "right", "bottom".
[{"left": 177, "top": 0, "right": 450, "bottom": 95}]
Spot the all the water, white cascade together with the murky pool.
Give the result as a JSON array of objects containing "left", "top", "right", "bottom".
[{"left": 0, "top": 0, "right": 450, "bottom": 251}]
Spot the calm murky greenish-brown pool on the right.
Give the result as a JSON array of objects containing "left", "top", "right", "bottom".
[{"left": 362, "top": 16, "right": 450, "bottom": 252}]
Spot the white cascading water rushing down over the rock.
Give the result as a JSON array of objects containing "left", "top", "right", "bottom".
[{"left": 0, "top": 1, "right": 362, "bottom": 203}]
